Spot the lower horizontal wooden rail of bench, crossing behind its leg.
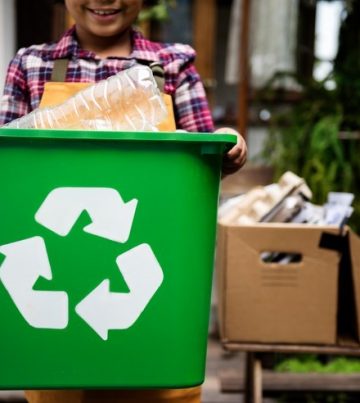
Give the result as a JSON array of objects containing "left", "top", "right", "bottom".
[{"left": 220, "top": 371, "right": 360, "bottom": 393}]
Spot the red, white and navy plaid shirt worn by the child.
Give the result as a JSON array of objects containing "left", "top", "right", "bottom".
[{"left": 0, "top": 27, "right": 214, "bottom": 132}]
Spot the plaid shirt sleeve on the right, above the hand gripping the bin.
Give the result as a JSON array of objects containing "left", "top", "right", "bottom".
[{"left": 174, "top": 64, "right": 214, "bottom": 133}]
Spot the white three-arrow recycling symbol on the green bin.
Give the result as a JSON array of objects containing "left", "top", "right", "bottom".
[{"left": 0, "top": 187, "right": 163, "bottom": 340}]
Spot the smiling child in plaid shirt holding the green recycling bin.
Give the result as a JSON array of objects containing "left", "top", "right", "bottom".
[{"left": 0, "top": 0, "right": 247, "bottom": 403}]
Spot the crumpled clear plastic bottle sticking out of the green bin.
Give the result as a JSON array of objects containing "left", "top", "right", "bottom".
[{"left": 5, "top": 65, "right": 167, "bottom": 131}]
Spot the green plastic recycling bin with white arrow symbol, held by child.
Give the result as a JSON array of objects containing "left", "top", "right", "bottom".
[{"left": 0, "top": 128, "right": 236, "bottom": 389}]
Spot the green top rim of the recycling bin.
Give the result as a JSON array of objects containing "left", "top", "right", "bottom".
[{"left": 0, "top": 127, "right": 237, "bottom": 148}]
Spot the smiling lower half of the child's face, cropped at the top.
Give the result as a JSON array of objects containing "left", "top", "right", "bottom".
[{"left": 65, "top": 0, "right": 143, "bottom": 37}]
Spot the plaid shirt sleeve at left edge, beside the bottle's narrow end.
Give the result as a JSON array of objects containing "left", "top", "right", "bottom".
[{"left": 0, "top": 50, "right": 30, "bottom": 126}]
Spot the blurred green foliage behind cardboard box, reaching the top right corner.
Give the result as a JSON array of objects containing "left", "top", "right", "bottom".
[{"left": 261, "top": 0, "right": 360, "bottom": 231}]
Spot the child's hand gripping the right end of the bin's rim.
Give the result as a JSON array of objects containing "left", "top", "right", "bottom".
[{"left": 215, "top": 127, "right": 247, "bottom": 176}]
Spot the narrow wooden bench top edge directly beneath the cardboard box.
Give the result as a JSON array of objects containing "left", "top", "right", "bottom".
[{"left": 223, "top": 343, "right": 360, "bottom": 356}]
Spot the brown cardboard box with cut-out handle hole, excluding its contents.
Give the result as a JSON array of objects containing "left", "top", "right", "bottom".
[{"left": 217, "top": 223, "right": 360, "bottom": 344}]
